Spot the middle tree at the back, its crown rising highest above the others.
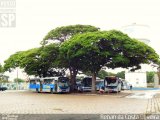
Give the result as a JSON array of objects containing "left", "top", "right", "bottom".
[{"left": 41, "top": 25, "right": 99, "bottom": 91}]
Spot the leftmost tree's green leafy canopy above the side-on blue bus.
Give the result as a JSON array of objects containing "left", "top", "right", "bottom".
[{"left": 4, "top": 44, "right": 62, "bottom": 77}]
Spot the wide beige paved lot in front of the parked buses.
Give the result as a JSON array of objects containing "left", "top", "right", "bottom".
[{"left": 0, "top": 91, "right": 148, "bottom": 114}]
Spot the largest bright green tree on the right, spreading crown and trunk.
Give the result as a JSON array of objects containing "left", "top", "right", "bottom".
[{"left": 65, "top": 30, "right": 159, "bottom": 92}]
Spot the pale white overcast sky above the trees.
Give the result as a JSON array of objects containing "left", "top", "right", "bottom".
[{"left": 0, "top": 0, "right": 160, "bottom": 80}]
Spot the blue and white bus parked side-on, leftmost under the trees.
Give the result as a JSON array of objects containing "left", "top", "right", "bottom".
[{"left": 29, "top": 77, "right": 70, "bottom": 93}]
